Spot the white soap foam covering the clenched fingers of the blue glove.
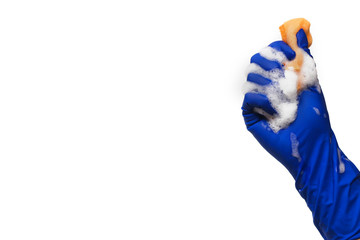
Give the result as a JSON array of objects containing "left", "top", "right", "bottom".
[{"left": 243, "top": 47, "right": 320, "bottom": 132}]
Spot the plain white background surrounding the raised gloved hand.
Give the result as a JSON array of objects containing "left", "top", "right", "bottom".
[{"left": 0, "top": 0, "right": 360, "bottom": 240}]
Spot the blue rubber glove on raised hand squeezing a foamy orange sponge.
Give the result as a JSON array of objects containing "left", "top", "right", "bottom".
[{"left": 242, "top": 30, "right": 360, "bottom": 240}]
